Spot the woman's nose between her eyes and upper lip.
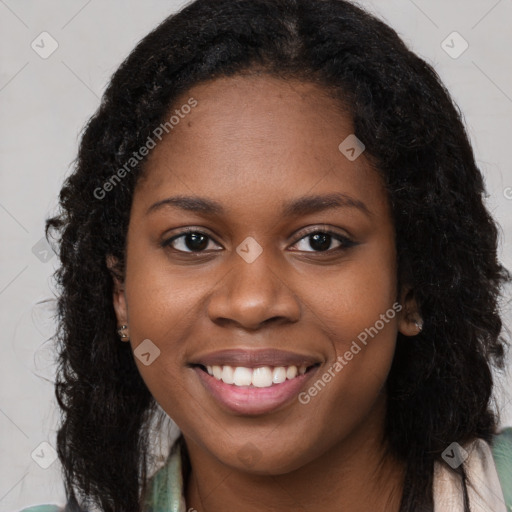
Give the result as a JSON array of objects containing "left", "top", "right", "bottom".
[{"left": 208, "top": 246, "right": 301, "bottom": 330}]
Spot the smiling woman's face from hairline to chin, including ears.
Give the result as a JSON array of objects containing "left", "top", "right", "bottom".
[{"left": 114, "top": 76, "right": 412, "bottom": 474}]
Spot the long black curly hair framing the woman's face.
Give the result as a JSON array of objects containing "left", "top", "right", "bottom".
[{"left": 46, "top": 0, "right": 510, "bottom": 512}]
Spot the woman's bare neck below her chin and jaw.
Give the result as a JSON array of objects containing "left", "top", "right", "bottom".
[{"left": 185, "top": 400, "right": 405, "bottom": 512}]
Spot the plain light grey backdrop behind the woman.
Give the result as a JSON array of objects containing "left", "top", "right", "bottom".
[{"left": 0, "top": 0, "right": 512, "bottom": 511}]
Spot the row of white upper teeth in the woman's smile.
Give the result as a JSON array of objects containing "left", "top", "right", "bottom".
[{"left": 206, "top": 365, "right": 307, "bottom": 388}]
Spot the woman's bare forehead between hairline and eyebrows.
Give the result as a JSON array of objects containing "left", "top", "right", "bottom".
[{"left": 132, "top": 75, "right": 388, "bottom": 220}]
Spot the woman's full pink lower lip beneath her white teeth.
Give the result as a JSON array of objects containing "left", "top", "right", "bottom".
[{"left": 194, "top": 366, "right": 318, "bottom": 415}]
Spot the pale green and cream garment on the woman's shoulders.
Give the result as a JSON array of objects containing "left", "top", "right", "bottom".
[{"left": 21, "top": 427, "right": 512, "bottom": 512}]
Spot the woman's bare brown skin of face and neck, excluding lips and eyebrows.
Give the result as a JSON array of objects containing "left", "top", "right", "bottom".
[{"left": 107, "top": 75, "right": 418, "bottom": 512}]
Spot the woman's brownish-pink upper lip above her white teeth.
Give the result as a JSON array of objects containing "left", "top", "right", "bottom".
[{"left": 191, "top": 348, "right": 320, "bottom": 368}]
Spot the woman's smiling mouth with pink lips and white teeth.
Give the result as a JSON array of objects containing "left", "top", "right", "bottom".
[{"left": 188, "top": 349, "right": 322, "bottom": 415}]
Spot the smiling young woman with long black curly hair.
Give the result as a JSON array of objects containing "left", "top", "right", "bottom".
[{"left": 22, "top": 0, "right": 512, "bottom": 512}]
